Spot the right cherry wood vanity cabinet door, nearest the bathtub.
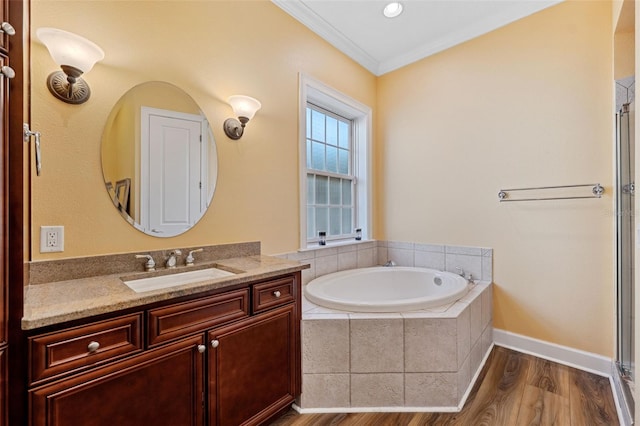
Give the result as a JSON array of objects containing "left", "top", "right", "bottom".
[{"left": 208, "top": 304, "right": 297, "bottom": 426}]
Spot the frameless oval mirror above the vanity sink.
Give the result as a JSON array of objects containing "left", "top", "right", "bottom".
[{"left": 102, "top": 81, "right": 218, "bottom": 237}]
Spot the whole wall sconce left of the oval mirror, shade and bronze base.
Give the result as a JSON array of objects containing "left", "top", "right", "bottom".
[{"left": 36, "top": 28, "right": 104, "bottom": 104}]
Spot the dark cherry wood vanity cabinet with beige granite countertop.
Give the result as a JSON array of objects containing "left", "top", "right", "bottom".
[{"left": 23, "top": 250, "right": 307, "bottom": 426}]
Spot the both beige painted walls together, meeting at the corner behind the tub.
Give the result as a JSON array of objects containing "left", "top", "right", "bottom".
[{"left": 31, "top": 0, "right": 614, "bottom": 356}]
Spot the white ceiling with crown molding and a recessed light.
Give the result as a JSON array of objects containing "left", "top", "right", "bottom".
[{"left": 272, "top": 0, "right": 562, "bottom": 75}]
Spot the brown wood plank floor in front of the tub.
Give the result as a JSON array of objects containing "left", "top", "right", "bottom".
[{"left": 272, "top": 346, "right": 619, "bottom": 426}]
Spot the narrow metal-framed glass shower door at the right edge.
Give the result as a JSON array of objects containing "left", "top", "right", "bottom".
[{"left": 616, "top": 103, "right": 635, "bottom": 381}]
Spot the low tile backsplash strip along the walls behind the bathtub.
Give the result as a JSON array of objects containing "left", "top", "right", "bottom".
[{"left": 279, "top": 241, "right": 493, "bottom": 284}]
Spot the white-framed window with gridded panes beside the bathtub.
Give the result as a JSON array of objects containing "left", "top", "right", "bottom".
[{"left": 300, "top": 76, "right": 371, "bottom": 248}]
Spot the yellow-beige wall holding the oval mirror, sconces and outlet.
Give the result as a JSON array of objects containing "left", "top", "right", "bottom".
[{"left": 31, "top": 0, "right": 375, "bottom": 259}]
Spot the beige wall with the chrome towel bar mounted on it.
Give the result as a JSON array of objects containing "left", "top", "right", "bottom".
[{"left": 377, "top": 1, "right": 614, "bottom": 356}]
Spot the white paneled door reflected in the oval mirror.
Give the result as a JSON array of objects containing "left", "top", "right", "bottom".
[{"left": 140, "top": 107, "right": 203, "bottom": 237}]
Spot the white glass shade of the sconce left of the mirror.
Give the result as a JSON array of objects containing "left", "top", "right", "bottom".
[{"left": 36, "top": 28, "right": 104, "bottom": 73}]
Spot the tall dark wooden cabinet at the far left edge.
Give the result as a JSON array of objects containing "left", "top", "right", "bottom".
[{"left": 6, "top": 0, "right": 29, "bottom": 426}]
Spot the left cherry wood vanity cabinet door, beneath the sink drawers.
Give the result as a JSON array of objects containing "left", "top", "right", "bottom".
[{"left": 29, "top": 335, "right": 204, "bottom": 426}]
